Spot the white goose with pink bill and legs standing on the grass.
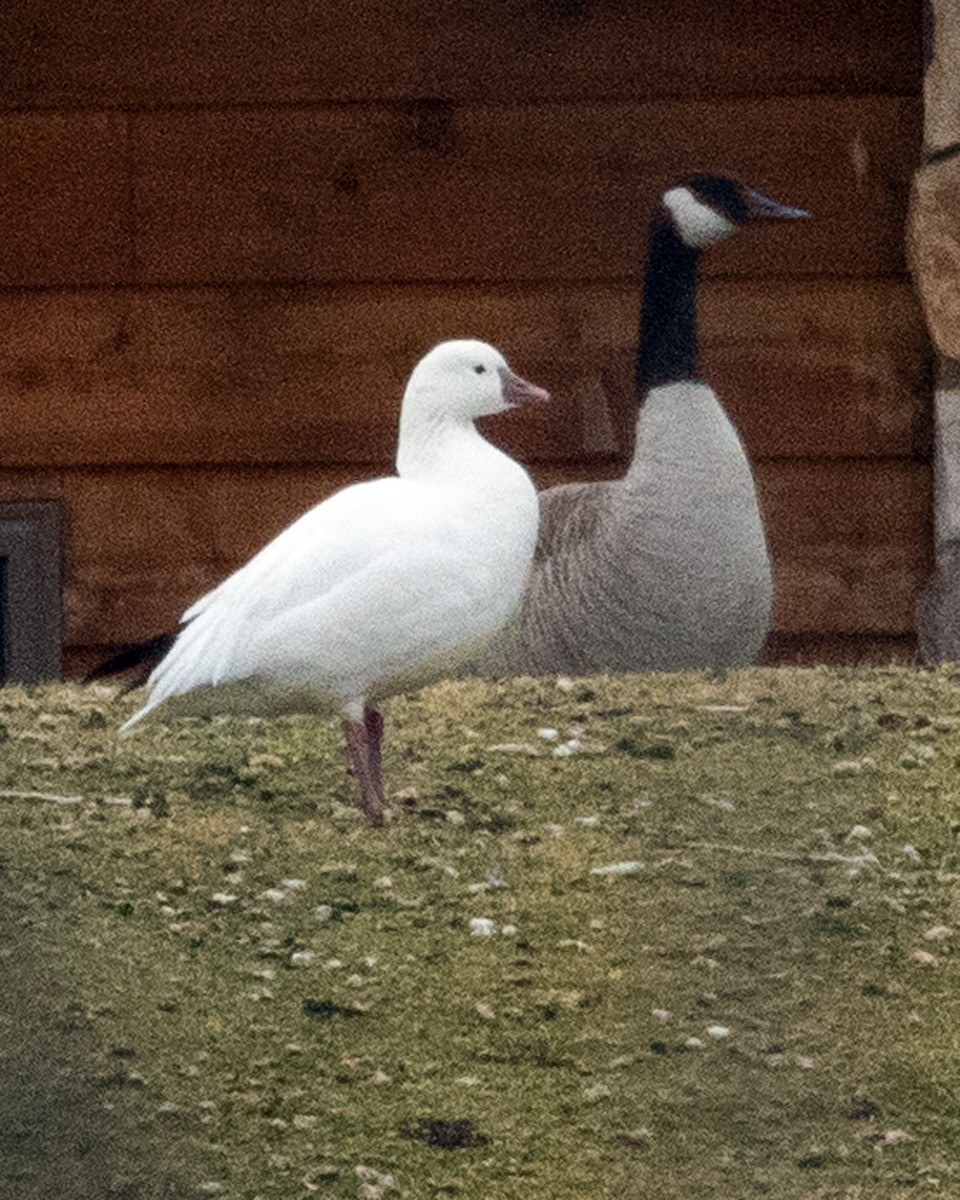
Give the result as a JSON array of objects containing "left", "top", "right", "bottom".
[{"left": 124, "top": 341, "right": 548, "bottom": 822}]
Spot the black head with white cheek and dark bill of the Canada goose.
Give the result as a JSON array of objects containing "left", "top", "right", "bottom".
[{"left": 662, "top": 175, "right": 810, "bottom": 250}]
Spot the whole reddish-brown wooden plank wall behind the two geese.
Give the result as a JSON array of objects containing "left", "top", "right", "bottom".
[{"left": 0, "top": 0, "right": 931, "bottom": 668}]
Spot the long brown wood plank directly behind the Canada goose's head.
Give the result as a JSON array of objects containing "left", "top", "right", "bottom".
[{"left": 131, "top": 97, "right": 920, "bottom": 286}]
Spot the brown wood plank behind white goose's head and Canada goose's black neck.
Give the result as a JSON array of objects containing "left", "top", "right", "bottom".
[{"left": 0, "top": 281, "right": 930, "bottom": 469}]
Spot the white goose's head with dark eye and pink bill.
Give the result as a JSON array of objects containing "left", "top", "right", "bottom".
[{"left": 403, "top": 338, "right": 550, "bottom": 421}]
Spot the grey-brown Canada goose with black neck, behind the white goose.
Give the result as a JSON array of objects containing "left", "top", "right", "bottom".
[{"left": 466, "top": 175, "right": 808, "bottom": 674}]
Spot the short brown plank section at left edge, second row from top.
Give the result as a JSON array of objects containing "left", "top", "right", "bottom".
[{"left": 0, "top": 113, "right": 133, "bottom": 287}]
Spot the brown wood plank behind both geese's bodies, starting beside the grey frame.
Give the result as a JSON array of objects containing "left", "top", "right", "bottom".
[{"left": 62, "top": 461, "right": 931, "bottom": 646}]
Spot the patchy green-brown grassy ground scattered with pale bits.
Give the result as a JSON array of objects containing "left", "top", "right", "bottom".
[{"left": 0, "top": 668, "right": 960, "bottom": 1200}]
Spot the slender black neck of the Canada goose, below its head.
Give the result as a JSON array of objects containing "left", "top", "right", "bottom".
[{"left": 635, "top": 215, "right": 700, "bottom": 402}]
